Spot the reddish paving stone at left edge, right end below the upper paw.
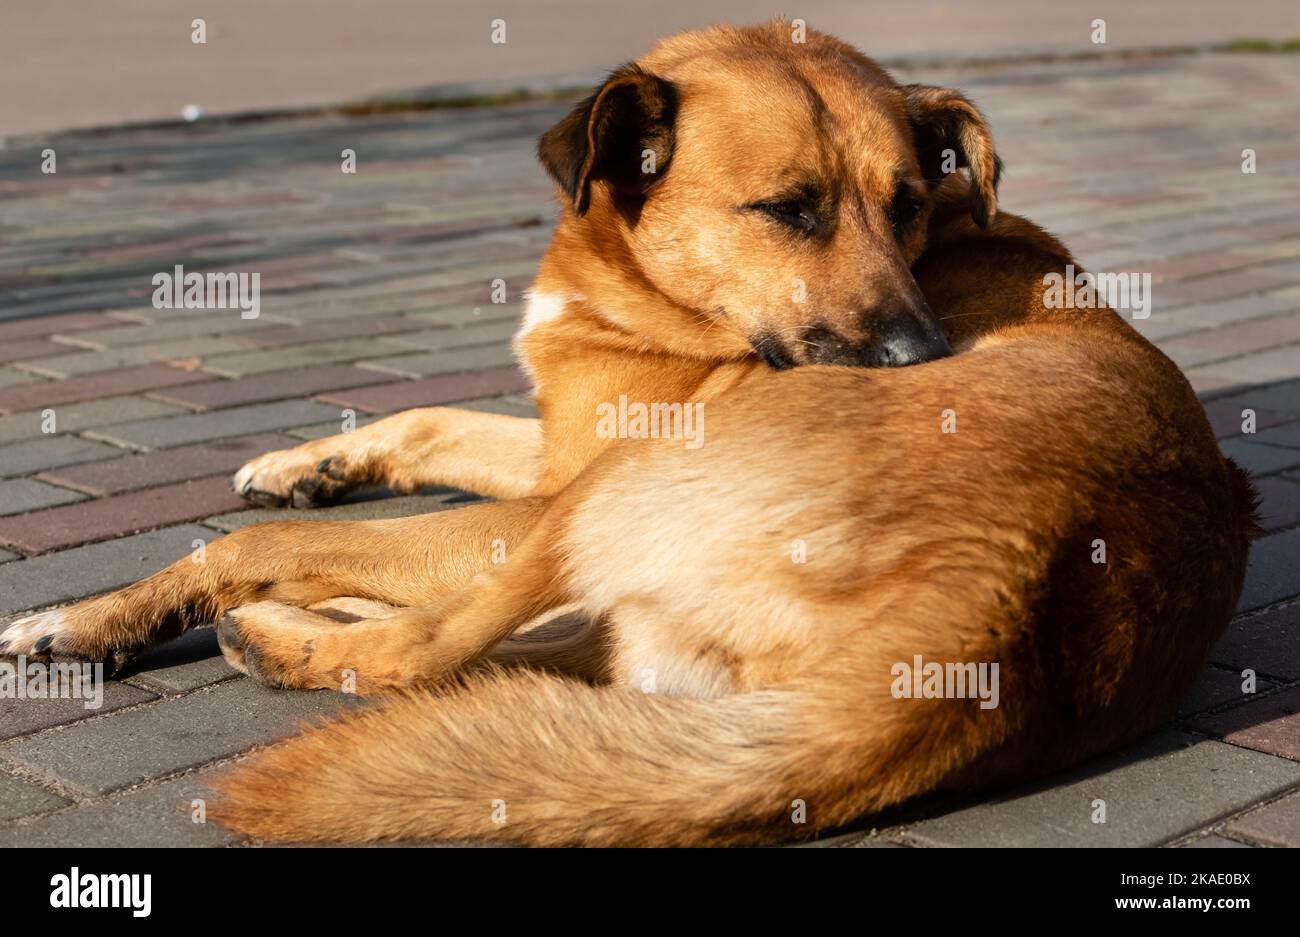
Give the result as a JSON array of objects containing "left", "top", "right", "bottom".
[{"left": 0, "top": 474, "right": 244, "bottom": 554}]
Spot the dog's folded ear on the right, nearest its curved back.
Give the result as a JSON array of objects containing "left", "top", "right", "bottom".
[{"left": 902, "top": 84, "right": 1002, "bottom": 227}]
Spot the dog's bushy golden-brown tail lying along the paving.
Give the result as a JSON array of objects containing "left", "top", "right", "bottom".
[{"left": 211, "top": 647, "right": 997, "bottom": 846}]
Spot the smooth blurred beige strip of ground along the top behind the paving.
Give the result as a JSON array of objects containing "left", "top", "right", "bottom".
[{"left": 0, "top": 0, "right": 1300, "bottom": 135}]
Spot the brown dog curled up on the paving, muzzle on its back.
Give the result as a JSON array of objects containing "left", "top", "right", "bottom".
[{"left": 3, "top": 22, "right": 1255, "bottom": 845}]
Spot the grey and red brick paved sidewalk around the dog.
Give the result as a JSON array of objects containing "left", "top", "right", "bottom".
[{"left": 0, "top": 47, "right": 1300, "bottom": 846}]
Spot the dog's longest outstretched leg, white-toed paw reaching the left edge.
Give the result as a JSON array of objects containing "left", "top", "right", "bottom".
[{"left": 0, "top": 498, "right": 546, "bottom": 659}]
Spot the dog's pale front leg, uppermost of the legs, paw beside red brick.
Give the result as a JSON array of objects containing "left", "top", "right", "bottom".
[{"left": 231, "top": 407, "right": 542, "bottom": 507}]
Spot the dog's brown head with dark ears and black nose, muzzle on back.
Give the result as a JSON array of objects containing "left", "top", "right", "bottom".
[{"left": 538, "top": 21, "right": 1000, "bottom": 368}]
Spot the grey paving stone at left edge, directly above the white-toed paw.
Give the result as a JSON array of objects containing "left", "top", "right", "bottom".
[{"left": 0, "top": 524, "right": 218, "bottom": 626}]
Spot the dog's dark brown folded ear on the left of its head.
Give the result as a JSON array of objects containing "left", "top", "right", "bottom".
[{"left": 537, "top": 65, "right": 677, "bottom": 217}]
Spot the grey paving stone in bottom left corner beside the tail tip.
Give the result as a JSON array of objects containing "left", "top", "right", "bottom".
[{"left": 0, "top": 772, "right": 238, "bottom": 849}]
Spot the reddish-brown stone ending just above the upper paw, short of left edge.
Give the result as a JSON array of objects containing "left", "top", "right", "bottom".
[{"left": 38, "top": 433, "right": 302, "bottom": 495}]
